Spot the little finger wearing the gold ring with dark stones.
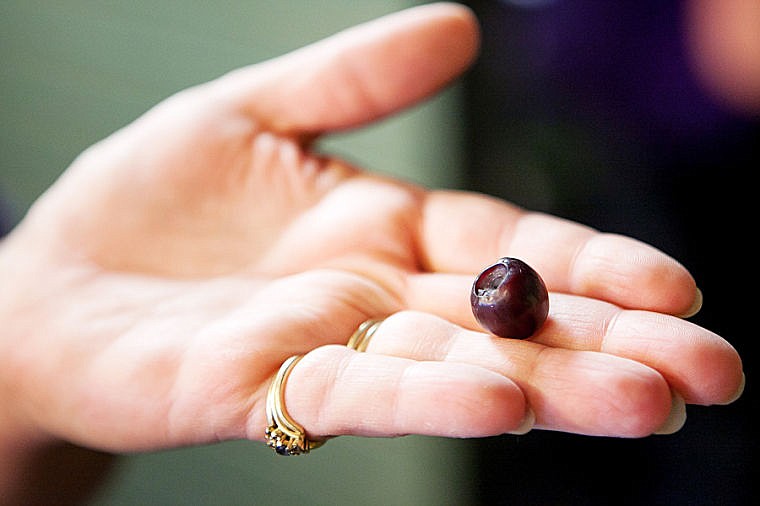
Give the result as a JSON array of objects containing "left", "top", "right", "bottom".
[{"left": 258, "top": 345, "right": 532, "bottom": 438}]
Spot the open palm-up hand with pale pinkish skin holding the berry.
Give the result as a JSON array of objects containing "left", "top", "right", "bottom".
[{"left": 0, "top": 4, "right": 743, "bottom": 502}]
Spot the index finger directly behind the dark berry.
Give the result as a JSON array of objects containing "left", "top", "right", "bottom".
[{"left": 419, "top": 191, "right": 701, "bottom": 315}]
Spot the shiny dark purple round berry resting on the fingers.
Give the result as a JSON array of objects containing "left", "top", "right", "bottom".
[{"left": 470, "top": 257, "right": 549, "bottom": 339}]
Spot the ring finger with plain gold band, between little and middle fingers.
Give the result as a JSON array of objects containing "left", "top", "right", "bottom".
[{"left": 350, "top": 312, "right": 674, "bottom": 437}]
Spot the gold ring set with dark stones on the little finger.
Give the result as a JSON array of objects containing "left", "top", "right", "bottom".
[{"left": 265, "top": 355, "right": 325, "bottom": 455}]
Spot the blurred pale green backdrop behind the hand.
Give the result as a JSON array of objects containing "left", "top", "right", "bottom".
[{"left": 0, "top": 0, "right": 474, "bottom": 506}]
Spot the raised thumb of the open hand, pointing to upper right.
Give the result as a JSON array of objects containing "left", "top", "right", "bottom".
[{"left": 215, "top": 3, "right": 478, "bottom": 135}]
